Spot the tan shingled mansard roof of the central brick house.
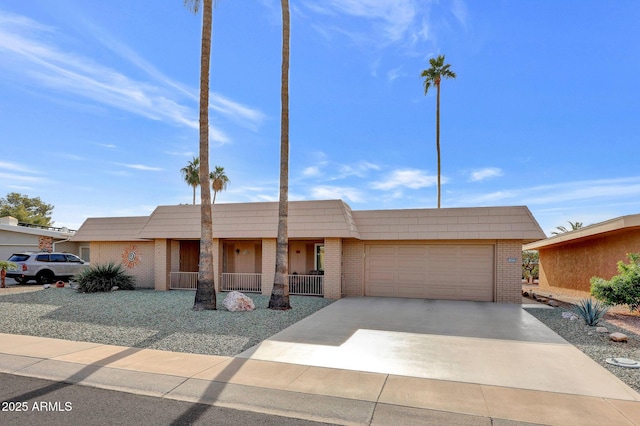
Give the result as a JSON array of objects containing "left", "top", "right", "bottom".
[{"left": 72, "top": 200, "right": 545, "bottom": 242}]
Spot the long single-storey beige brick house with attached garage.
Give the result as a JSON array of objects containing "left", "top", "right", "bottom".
[{"left": 72, "top": 200, "right": 545, "bottom": 303}]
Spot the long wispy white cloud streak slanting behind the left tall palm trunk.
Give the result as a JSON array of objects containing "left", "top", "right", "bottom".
[{"left": 0, "top": 11, "right": 264, "bottom": 143}]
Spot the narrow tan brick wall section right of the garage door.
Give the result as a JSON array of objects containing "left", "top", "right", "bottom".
[{"left": 496, "top": 240, "right": 522, "bottom": 303}]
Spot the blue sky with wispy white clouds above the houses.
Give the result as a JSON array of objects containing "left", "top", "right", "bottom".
[{"left": 0, "top": 0, "right": 640, "bottom": 234}]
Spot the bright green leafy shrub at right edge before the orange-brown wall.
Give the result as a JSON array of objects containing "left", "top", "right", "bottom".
[{"left": 591, "top": 253, "right": 640, "bottom": 311}]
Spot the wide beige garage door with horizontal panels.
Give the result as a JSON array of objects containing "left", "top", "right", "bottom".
[{"left": 365, "top": 244, "right": 494, "bottom": 302}]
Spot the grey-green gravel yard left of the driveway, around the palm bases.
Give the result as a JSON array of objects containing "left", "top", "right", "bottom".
[{"left": 0, "top": 286, "right": 331, "bottom": 356}]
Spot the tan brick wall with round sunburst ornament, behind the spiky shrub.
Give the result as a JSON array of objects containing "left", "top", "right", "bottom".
[{"left": 90, "top": 241, "right": 155, "bottom": 288}]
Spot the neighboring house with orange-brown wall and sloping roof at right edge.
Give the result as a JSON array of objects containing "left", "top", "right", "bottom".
[{"left": 524, "top": 214, "right": 640, "bottom": 294}]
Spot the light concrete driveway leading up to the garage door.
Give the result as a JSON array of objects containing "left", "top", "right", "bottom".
[{"left": 238, "top": 297, "right": 640, "bottom": 401}]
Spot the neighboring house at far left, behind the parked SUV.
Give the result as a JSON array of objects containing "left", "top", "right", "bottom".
[{"left": 0, "top": 216, "right": 89, "bottom": 260}]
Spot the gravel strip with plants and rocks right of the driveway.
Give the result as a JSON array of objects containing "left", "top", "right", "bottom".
[{"left": 526, "top": 306, "right": 640, "bottom": 392}]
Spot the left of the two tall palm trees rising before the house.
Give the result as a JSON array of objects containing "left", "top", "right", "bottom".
[{"left": 184, "top": 0, "right": 216, "bottom": 311}]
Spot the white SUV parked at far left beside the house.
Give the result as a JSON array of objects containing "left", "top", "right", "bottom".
[{"left": 7, "top": 253, "right": 89, "bottom": 284}]
